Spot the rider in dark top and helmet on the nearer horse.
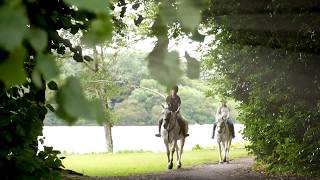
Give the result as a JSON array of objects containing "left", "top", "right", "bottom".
[{"left": 155, "top": 85, "right": 189, "bottom": 137}]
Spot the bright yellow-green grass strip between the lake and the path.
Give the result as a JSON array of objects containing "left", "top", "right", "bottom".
[{"left": 63, "top": 148, "right": 248, "bottom": 176}]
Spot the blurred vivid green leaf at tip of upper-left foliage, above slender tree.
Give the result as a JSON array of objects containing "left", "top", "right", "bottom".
[{"left": 83, "top": 15, "right": 112, "bottom": 45}]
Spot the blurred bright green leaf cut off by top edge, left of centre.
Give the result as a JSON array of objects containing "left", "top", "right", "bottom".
[{"left": 64, "top": 0, "right": 109, "bottom": 13}]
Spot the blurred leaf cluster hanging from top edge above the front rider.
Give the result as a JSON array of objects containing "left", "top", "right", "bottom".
[{"left": 142, "top": 0, "right": 208, "bottom": 88}]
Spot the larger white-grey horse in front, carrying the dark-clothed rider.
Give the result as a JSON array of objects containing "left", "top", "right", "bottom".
[{"left": 161, "top": 106, "right": 188, "bottom": 169}]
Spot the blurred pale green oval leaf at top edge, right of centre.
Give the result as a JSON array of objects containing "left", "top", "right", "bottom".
[{"left": 178, "top": 0, "right": 201, "bottom": 30}]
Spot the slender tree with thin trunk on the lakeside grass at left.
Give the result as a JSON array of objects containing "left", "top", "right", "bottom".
[{"left": 79, "top": 45, "right": 119, "bottom": 152}]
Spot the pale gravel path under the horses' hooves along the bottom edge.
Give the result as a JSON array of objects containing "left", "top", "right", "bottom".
[{"left": 63, "top": 158, "right": 320, "bottom": 180}]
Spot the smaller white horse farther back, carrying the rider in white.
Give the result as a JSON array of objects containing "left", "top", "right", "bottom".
[{"left": 216, "top": 116, "right": 232, "bottom": 163}]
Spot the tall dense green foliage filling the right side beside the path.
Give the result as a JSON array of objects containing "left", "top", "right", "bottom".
[{"left": 203, "top": 0, "right": 320, "bottom": 175}]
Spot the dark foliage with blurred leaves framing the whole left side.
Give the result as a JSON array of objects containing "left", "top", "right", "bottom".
[{"left": 0, "top": 0, "right": 112, "bottom": 179}]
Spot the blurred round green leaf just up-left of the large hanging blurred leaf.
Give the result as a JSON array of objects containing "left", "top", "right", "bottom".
[{"left": 36, "top": 54, "right": 59, "bottom": 80}]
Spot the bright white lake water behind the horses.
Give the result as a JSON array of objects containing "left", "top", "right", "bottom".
[{"left": 40, "top": 124, "right": 244, "bottom": 153}]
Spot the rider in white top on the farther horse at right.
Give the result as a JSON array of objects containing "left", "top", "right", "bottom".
[{"left": 211, "top": 100, "right": 235, "bottom": 139}]
